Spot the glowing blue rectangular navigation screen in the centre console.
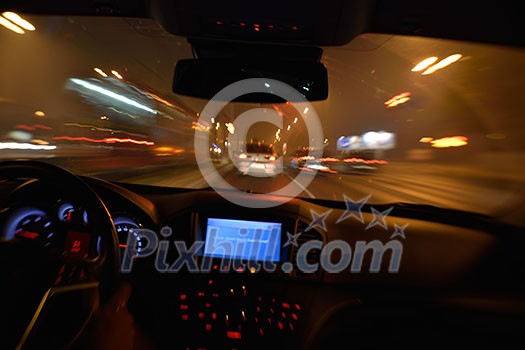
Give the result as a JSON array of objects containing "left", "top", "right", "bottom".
[{"left": 203, "top": 218, "right": 282, "bottom": 262}]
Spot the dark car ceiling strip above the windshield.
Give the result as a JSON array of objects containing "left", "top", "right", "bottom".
[{"left": 0, "top": 0, "right": 525, "bottom": 46}]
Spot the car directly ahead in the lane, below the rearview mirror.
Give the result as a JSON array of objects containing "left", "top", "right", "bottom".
[{"left": 237, "top": 142, "right": 282, "bottom": 177}]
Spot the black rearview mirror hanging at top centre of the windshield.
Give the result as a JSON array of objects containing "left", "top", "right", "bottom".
[{"left": 173, "top": 59, "right": 328, "bottom": 103}]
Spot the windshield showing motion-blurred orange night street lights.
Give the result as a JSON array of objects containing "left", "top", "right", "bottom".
[{"left": 0, "top": 15, "right": 525, "bottom": 226}]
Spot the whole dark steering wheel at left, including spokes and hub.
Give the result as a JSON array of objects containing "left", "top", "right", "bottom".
[{"left": 0, "top": 161, "right": 119, "bottom": 349}]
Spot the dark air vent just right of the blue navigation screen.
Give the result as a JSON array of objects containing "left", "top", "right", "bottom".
[{"left": 290, "top": 220, "right": 324, "bottom": 278}]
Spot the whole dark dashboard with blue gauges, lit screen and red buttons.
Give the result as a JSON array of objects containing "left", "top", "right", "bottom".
[{"left": 1, "top": 178, "right": 525, "bottom": 349}]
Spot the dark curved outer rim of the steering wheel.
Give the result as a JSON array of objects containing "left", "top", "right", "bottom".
[{"left": 0, "top": 161, "right": 120, "bottom": 347}]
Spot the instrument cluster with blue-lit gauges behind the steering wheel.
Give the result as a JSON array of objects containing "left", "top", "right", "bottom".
[{"left": 0, "top": 182, "right": 148, "bottom": 268}]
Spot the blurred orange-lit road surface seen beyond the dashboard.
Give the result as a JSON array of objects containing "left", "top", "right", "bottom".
[{"left": 3, "top": 155, "right": 525, "bottom": 225}]
